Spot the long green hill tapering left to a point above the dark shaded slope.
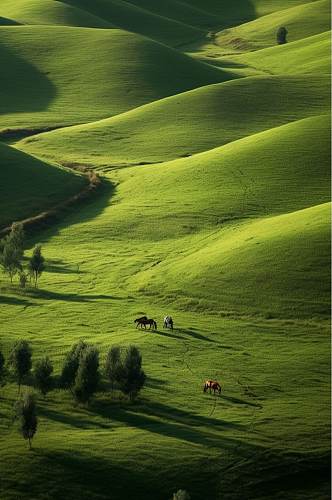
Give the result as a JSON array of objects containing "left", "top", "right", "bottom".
[{"left": 19, "top": 76, "right": 330, "bottom": 166}]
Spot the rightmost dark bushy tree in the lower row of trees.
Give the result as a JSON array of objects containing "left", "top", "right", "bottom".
[{"left": 120, "top": 346, "right": 146, "bottom": 401}]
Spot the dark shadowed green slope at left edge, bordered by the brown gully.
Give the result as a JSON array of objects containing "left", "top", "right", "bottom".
[{"left": 0, "top": 143, "right": 86, "bottom": 228}]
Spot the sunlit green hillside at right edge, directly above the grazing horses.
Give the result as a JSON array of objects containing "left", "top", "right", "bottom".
[{"left": 131, "top": 203, "right": 331, "bottom": 317}]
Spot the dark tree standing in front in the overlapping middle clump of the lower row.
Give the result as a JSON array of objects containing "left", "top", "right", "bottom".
[{"left": 74, "top": 346, "right": 99, "bottom": 403}]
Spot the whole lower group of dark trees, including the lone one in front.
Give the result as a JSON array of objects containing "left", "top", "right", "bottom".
[{"left": 0, "top": 340, "right": 146, "bottom": 449}]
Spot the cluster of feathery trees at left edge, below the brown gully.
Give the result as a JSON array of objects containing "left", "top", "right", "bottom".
[{"left": 0, "top": 222, "right": 45, "bottom": 288}]
